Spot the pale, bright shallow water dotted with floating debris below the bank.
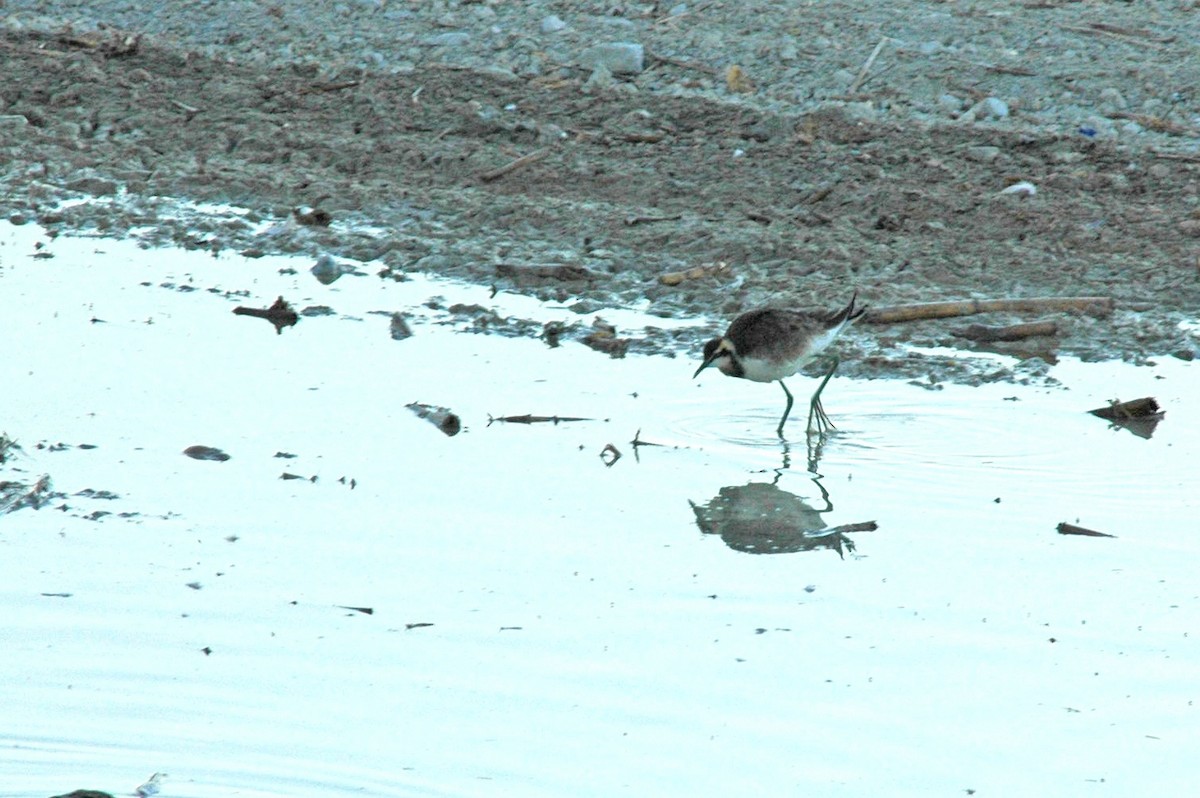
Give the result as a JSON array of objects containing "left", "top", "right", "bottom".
[{"left": 0, "top": 220, "right": 1200, "bottom": 797}]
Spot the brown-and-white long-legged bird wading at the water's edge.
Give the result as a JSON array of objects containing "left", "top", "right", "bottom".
[{"left": 692, "top": 292, "right": 866, "bottom": 438}]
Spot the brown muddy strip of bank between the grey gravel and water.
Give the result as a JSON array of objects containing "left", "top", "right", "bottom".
[{"left": 0, "top": 11, "right": 1200, "bottom": 382}]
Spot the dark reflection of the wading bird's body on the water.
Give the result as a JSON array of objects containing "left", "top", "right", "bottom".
[{"left": 690, "top": 482, "right": 875, "bottom": 557}]
